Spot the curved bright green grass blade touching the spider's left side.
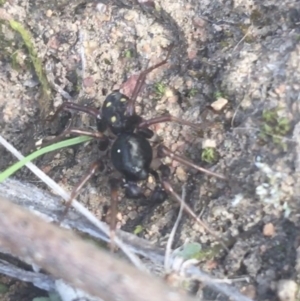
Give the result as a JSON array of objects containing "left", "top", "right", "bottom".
[{"left": 0, "top": 136, "right": 93, "bottom": 183}]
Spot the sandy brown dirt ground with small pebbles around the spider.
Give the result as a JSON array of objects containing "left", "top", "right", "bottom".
[{"left": 0, "top": 0, "right": 300, "bottom": 300}]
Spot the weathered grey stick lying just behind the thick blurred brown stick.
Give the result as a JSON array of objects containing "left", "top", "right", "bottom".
[{"left": 0, "top": 178, "right": 164, "bottom": 262}]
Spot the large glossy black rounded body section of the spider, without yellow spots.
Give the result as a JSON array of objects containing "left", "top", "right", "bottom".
[{"left": 111, "top": 133, "right": 152, "bottom": 182}]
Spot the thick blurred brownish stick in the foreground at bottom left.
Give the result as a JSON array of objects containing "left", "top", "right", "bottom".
[{"left": 0, "top": 197, "right": 196, "bottom": 301}]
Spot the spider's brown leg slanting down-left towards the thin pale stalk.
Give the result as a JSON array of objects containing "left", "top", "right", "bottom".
[{"left": 59, "top": 160, "right": 104, "bottom": 223}]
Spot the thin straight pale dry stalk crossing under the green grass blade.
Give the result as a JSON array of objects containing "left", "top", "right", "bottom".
[{"left": 0, "top": 135, "right": 144, "bottom": 269}]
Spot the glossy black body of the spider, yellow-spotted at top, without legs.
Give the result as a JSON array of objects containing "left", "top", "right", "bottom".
[{"left": 98, "top": 91, "right": 159, "bottom": 199}]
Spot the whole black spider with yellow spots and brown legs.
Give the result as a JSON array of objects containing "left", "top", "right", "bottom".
[{"left": 48, "top": 47, "right": 225, "bottom": 239}]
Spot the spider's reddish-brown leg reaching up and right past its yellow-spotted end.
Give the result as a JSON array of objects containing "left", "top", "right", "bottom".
[{"left": 126, "top": 45, "right": 173, "bottom": 116}]
